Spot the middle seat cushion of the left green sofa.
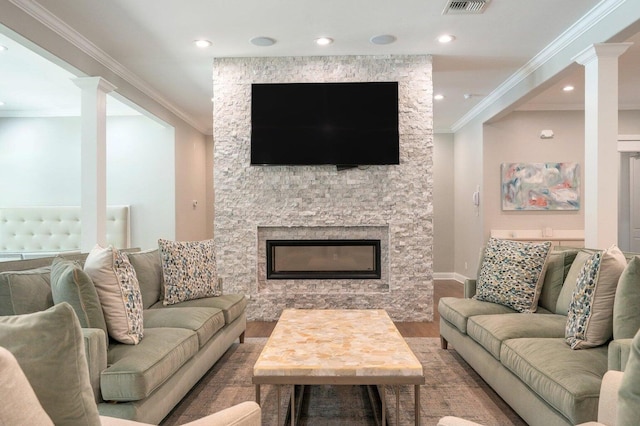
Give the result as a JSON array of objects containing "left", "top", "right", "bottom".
[{"left": 144, "top": 307, "right": 224, "bottom": 347}]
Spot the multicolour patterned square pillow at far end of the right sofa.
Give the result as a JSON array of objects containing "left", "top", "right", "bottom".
[{"left": 473, "top": 238, "right": 551, "bottom": 312}]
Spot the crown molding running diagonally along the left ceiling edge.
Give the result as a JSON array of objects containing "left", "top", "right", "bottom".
[{"left": 9, "top": 0, "right": 208, "bottom": 134}]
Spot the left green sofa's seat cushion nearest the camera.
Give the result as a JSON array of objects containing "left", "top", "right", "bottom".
[{"left": 100, "top": 328, "right": 199, "bottom": 401}]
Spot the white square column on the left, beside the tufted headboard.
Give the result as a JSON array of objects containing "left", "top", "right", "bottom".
[{"left": 74, "top": 77, "right": 116, "bottom": 252}]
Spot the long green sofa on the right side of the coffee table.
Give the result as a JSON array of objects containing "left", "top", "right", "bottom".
[{"left": 438, "top": 247, "right": 640, "bottom": 426}]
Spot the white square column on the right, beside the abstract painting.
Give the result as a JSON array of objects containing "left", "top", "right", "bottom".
[{"left": 574, "top": 43, "right": 631, "bottom": 248}]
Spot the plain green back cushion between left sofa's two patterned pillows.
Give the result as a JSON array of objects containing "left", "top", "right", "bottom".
[{"left": 127, "top": 249, "right": 164, "bottom": 309}]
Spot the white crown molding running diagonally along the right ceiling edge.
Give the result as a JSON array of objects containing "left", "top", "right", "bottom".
[{"left": 451, "top": 0, "right": 628, "bottom": 132}]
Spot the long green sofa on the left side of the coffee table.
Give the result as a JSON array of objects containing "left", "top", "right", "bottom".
[{"left": 0, "top": 250, "right": 247, "bottom": 424}]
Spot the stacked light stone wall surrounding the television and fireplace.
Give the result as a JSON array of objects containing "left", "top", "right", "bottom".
[{"left": 213, "top": 56, "right": 433, "bottom": 321}]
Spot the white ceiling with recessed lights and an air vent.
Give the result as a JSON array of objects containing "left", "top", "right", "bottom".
[{"left": 0, "top": 0, "right": 640, "bottom": 133}]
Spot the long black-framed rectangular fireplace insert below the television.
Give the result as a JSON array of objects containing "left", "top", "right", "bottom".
[{"left": 267, "top": 240, "right": 381, "bottom": 279}]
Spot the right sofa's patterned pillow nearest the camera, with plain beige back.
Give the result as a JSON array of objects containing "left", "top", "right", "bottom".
[{"left": 565, "top": 246, "right": 627, "bottom": 349}]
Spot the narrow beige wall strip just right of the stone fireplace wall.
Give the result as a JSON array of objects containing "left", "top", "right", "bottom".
[{"left": 433, "top": 133, "right": 455, "bottom": 272}]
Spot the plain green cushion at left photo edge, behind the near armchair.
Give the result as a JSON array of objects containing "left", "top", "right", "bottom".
[{"left": 0, "top": 266, "right": 53, "bottom": 315}]
